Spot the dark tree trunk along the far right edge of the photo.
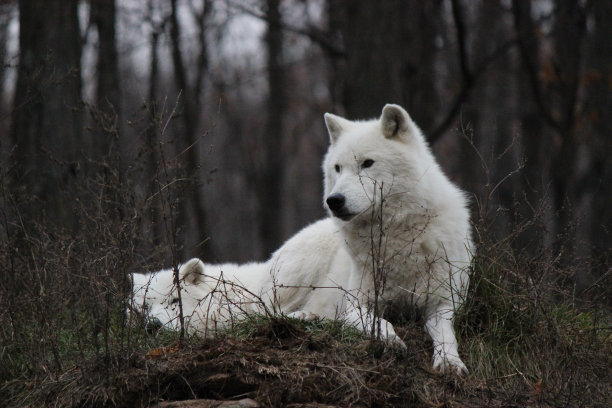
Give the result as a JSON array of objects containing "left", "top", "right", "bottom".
[{"left": 576, "top": 1, "right": 612, "bottom": 290}]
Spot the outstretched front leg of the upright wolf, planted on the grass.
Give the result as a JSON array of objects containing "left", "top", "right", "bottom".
[{"left": 425, "top": 305, "right": 469, "bottom": 376}]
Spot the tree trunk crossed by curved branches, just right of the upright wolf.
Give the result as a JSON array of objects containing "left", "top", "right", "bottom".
[{"left": 460, "top": 1, "right": 516, "bottom": 226}]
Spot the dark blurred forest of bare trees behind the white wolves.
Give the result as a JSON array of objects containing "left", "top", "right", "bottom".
[{"left": 0, "top": 0, "right": 612, "bottom": 300}]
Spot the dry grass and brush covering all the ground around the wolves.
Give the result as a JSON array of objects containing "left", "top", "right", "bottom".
[{"left": 0, "top": 118, "right": 612, "bottom": 407}]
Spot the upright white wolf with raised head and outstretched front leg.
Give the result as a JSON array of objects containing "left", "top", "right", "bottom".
[{"left": 323, "top": 105, "right": 473, "bottom": 374}]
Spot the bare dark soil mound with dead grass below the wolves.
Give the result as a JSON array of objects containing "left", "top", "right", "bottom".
[{"left": 9, "top": 321, "right": 610, "bottom": 407}]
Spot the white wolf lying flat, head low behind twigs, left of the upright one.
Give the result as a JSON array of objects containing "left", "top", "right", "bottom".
[{"left": 128, "top": 218, "right": 405, "bottom": 348}]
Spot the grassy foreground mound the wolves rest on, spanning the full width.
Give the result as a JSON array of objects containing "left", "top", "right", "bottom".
[{"left": 2, "top": 299, "right": 612, "bottom": 407}]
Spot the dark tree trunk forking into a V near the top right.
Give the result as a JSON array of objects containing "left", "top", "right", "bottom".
[{"left": 513, "top": 0, "right": 586, "bottom": 264}]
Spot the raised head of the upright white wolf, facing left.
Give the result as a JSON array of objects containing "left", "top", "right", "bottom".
[{"left": 323, "top": 105, "right": 435, "bottom": 221}]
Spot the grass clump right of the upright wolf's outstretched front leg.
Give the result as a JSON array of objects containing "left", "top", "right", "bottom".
[{"left": 456, "top": 258, "right": 612, "bottom": 406}]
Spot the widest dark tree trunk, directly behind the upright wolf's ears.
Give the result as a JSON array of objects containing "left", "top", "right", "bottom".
[{"left": 326, "top": 0, "right": 500, "bottom": 143}]
